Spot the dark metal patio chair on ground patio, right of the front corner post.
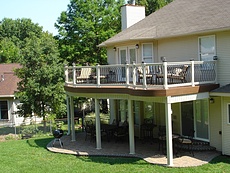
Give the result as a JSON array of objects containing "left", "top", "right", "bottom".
[{"left": 176, "top": 129, "right": 195, "bottom": 156}]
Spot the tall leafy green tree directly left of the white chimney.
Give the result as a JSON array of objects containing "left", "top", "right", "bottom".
[{"left": 56, "top": 0, "right": 124, "bottom": 65}]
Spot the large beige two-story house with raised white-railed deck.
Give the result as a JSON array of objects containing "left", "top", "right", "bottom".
[{"left": 65, "top": 0, "right": 230, "bottom": 166}]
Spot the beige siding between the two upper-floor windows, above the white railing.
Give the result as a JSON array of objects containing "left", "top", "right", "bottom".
[{"left": 158, "top": 36, "right": 198, "bottom": 61}]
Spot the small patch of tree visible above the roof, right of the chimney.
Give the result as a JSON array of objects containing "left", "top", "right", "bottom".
[{"left": 138, "top": 0, "right": 173, "bottom": 16}]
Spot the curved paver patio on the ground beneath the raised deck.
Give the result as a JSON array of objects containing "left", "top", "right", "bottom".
[{"left": 47, "top": 132, "right": 220, "bottom": 167}]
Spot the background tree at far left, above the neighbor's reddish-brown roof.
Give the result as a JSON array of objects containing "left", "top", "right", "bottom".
[{"left": 0, "top": 18, "right": 42, "bottom": 63}]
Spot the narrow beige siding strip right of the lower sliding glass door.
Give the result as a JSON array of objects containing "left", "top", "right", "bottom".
[{"left": 209, "top": 97, "right": 222, "bottom": 151}]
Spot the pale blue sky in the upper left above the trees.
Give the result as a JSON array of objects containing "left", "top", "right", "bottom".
[{"left": 0, "top": 0, "right": 70, "bottom": 35}]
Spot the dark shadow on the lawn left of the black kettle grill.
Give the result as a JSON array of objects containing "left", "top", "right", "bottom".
[{"left": 26, "top": 137, "right": 54, "bottom": 148}]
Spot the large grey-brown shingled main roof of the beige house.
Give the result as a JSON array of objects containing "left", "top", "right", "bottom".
[{"left": 99, "top": 0, "right": 230, "bottom": 47}]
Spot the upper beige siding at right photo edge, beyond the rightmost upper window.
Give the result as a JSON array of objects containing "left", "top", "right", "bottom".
[{"left": 216, "top": 31, "right": 230, "bottom": 86}]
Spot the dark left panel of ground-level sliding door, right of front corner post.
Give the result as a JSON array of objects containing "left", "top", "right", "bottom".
[{"left": 181, "top": 101, "right": 194, "bottom": 136}]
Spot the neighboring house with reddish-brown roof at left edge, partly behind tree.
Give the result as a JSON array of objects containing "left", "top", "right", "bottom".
[{"left": 0, "top": 63, "right": 41, "bottom": 126}]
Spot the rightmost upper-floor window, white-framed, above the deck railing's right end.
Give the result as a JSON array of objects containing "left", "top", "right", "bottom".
[{"left": 199, "top": 35, "right": 216, "bottom": 61}]
